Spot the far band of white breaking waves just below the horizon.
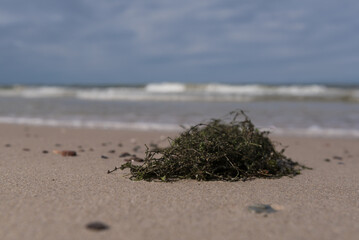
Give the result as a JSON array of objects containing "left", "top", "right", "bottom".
[{"left": 0, "top": 83, "right": 359, "bottom": 102}]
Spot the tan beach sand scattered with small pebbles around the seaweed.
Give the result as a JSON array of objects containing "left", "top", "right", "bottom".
[{"left": 0, "top": 124, "right": 359, "bottom": 240}]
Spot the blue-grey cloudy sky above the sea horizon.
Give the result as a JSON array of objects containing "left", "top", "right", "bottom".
[{"left": 0, "top": 0, "right": 359, "bottom": 84}]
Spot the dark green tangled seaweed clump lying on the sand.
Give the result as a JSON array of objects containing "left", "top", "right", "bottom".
[{"left": 120, "top": 111, "right": 305, "bottom": 181}]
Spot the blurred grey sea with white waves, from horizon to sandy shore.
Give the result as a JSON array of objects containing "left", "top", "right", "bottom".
[{"left": 0, "top": 82, "right": 359, "bottom": 138}]
